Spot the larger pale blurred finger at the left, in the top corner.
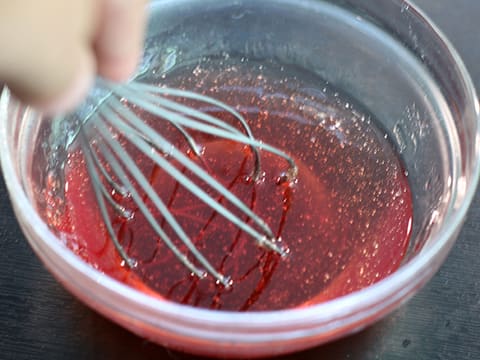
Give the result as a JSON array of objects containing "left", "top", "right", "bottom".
[{"left": 0, "top": 0, "right": 96, "bottom": 112}]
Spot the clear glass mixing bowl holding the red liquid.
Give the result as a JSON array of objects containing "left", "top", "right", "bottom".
[{"left": 0, "top": 0, "right": 480, "bottom": 357}]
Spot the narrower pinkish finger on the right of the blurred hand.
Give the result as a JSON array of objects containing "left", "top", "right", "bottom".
[{"left": 95, "top": 0, "right": 147, "bottom": 81}]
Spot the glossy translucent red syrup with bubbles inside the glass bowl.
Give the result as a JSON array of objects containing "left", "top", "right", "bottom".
[{"left": 47, "top": 60, "right": 412, "bottom": 311}]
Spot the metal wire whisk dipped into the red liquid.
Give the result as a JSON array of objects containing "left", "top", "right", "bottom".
[{"left": 60, "top": 81, "right": 297, "bottom": 287}]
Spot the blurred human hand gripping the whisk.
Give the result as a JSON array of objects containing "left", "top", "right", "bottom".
[{"left": 0, "top": 0, "right": 147, "bottom": 113}]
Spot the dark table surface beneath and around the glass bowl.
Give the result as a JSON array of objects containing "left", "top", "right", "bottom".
[{"left": 0, "top": 0, "right": 480, "bottom": 360}]
